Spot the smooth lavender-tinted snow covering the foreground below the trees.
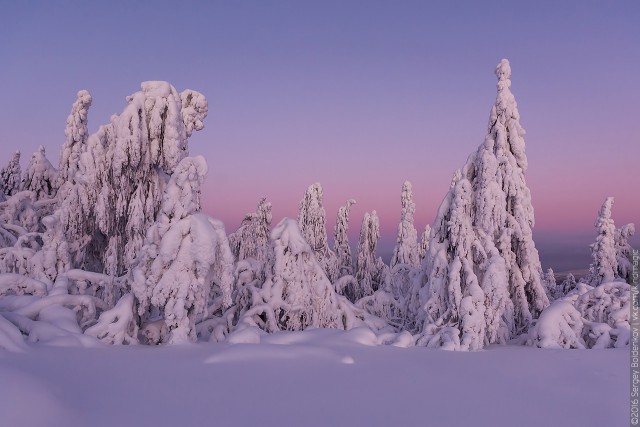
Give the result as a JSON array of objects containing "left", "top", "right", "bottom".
[{"left": 0, "top": 329, "right": 629, "bottom": 427}]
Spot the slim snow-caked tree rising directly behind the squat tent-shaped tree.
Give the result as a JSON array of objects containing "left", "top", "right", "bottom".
[{"left": 298, "top": 183, "right": 338, "bottom": 282}]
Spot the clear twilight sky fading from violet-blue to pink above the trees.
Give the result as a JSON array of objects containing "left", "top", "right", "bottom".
[{"left": 0, "top": 0, "right": 640, "bottom": 271}]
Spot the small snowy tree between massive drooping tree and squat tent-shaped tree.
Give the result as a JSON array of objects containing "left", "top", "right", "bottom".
[{"left": 229, "top": 197, "right": 272, "bottom": 265}]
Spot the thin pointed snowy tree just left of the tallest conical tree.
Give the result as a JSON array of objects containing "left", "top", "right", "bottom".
[{"left": 390, "top": 181, "right": 420, "bottom": 269}]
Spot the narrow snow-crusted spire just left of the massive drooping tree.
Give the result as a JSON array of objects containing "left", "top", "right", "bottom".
[{"left": 58, "top": 90, "right": 92, "bottom": 182}]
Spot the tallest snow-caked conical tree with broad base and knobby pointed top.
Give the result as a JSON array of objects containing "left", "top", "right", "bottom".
[{"left": 420, "top": 60, "right": 549, "bottom": 349}]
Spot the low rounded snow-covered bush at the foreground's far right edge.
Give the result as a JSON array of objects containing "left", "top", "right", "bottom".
[{"left": 526, "top": 282, "right": 631, "bottom": 348}]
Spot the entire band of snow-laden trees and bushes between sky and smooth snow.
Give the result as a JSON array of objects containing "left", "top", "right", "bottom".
[{"left": 0, "top": 60, "right": 634, "bottom": 350}]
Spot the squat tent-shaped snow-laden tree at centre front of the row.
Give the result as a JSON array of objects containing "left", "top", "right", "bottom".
[{"left": 238, "top": 218, "right": 364, "bottom": 332}]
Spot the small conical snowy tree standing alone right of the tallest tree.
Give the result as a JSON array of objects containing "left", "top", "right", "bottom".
[{"left": 588, "top": 197, "right": 618, "bottom": 287}]
